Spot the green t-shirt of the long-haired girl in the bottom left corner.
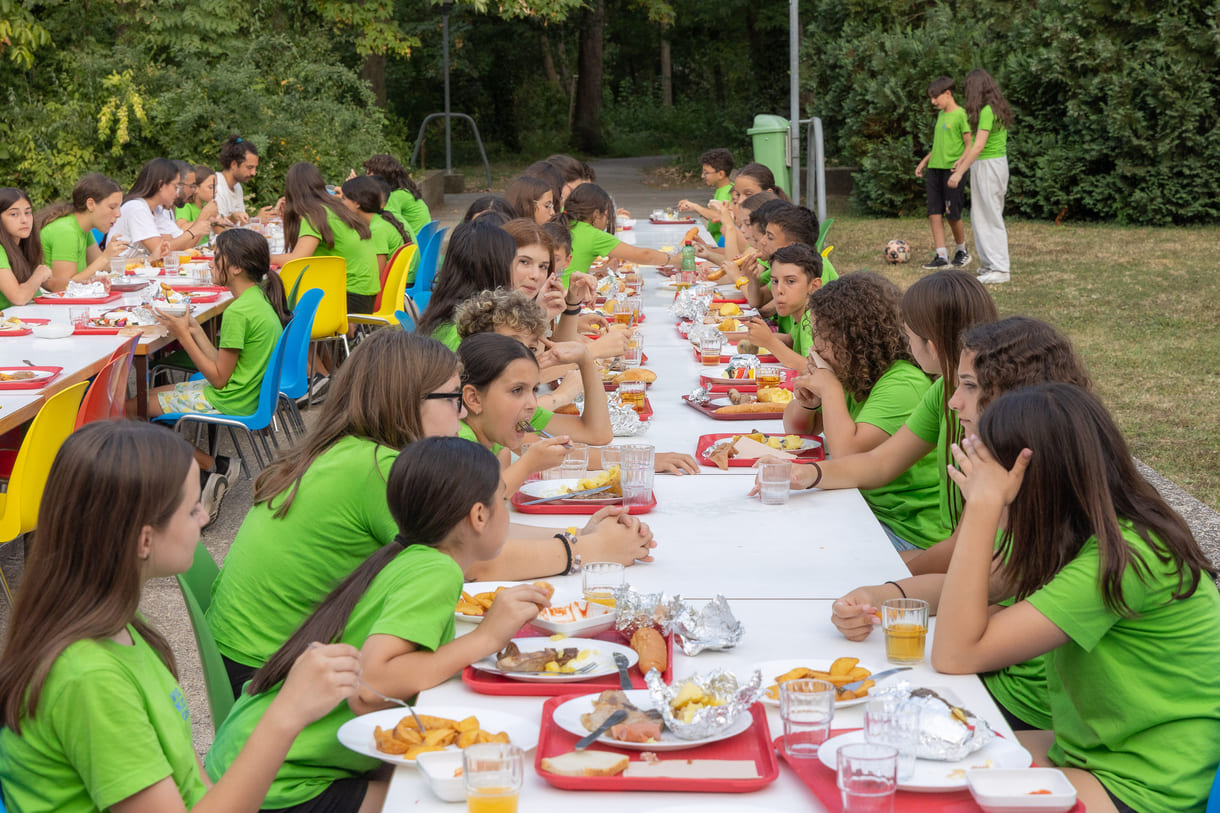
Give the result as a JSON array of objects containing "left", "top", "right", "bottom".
[{"left": 0, "top": 622, "right": 207, "bottom": 813}]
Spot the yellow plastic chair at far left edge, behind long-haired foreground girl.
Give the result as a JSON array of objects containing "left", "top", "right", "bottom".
[{"left": 0, "top": 381, "right": 89, "bottom": 604}]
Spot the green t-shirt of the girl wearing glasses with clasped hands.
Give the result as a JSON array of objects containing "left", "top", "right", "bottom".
[{"left": 207, "top": 436, "right": 398, "bottom": 667}]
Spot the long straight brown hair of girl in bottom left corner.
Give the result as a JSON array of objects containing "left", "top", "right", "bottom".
[{"left": 0, "top": 421, "right": 194, "bottom": 734}]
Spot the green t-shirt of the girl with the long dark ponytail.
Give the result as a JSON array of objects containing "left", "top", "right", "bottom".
[{"left": 206, "top": 544, "right": 462, "bottom": 808}]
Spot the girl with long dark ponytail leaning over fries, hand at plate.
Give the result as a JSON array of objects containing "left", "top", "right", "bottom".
[{"left": 207, "top": 437, "right": 549, "bottom": 813}]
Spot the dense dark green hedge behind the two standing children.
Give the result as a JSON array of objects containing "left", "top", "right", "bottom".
[{"left": 803, "top": 0, "right": 1220, "bottom": 225}]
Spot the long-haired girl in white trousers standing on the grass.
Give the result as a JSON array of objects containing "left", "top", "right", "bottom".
[{"left": 949, "top": 68, "right": 1013, "bottom": 284}]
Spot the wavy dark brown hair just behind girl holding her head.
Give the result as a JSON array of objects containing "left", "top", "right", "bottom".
[{"left": 961, "top": 316, "right": 1092, "bottom": 409}]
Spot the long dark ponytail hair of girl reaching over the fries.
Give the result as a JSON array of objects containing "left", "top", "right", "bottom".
[{"left": 249, "top": 434, "right": 508, "bottom": 695}]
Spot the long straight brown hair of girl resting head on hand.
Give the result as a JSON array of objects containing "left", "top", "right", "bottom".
[{"left": 978, "top": 383, "right": 1215, "bottom": 615}]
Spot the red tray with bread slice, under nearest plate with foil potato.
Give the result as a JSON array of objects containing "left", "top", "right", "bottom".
[{"left": 534, "top": 695, "right": 780, "bottom": 793}]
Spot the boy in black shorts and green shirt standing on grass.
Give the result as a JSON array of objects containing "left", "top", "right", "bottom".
[{"left": 915, "top": 76, "right": 970, "bottom": 271}]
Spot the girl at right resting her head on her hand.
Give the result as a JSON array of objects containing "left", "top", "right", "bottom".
[{"left": 931, "top": 383, "right": 1220, "bottom": 813}]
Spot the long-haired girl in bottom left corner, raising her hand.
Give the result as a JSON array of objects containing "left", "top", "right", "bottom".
[{"left": 0, "top": 421, "right": 359, "bottom": 813}]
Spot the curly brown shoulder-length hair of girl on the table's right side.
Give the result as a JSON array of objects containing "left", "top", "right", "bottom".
[{"left": 809, "top": 271, "right": 913, "bottom": 400}]
